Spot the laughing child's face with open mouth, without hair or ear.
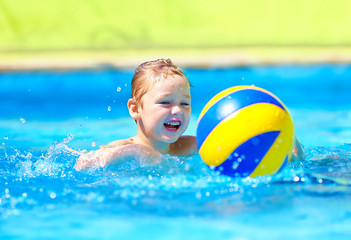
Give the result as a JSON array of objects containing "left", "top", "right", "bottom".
[{"left": 139, "top": 75, "right": 191, "bottom": 143}]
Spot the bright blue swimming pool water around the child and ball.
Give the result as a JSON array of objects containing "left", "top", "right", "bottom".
[{"left": 0, "top": 64, "right": 351, "bottom": 239}]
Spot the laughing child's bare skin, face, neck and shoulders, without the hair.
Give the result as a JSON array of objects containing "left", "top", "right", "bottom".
[{"left": 75, "top": 76, "right": 197, "bottom": 171}]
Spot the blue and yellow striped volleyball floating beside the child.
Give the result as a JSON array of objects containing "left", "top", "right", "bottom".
[{"left": 196, "top": 86, "right": 295, "bottom": 177}]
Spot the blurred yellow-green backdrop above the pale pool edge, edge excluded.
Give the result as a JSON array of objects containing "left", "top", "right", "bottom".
[{"left": 0, "top": 0, "right": 351, "bottom": 66}]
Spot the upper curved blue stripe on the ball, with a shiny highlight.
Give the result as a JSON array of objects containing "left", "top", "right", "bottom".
[{"left": 196, "top": 89, "right": 286, "bottom": 149}]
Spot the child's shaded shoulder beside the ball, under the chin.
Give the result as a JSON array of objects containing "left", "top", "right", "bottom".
[{"left": 170, "top": 136, "right": 197, "bottom": 155}]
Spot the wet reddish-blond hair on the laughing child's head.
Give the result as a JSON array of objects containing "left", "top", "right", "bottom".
[{"left": 132, "top": 58, "right": 190, "bottom": 102}]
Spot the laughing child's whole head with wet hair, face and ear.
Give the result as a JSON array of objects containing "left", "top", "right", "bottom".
[{"left": 128, "top": 59, "right": 191, "bottom": 146}]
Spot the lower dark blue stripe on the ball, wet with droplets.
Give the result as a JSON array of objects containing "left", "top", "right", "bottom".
[{"left": 215, "top": 131, "right": 280, "bottom": 177}]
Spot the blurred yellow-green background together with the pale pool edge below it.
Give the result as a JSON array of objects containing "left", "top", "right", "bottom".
[{"left": 0, "top": 0, "right": 351, "bottom": 68}]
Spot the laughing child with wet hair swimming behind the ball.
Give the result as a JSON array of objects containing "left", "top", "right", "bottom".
[{"left": 75, "top": 59, "right": 303, "bottom": 171}]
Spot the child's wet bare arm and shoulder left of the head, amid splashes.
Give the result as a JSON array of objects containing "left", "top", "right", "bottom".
[{"left": 74, "top": 140, "right": 162, "bottom": 171}]
